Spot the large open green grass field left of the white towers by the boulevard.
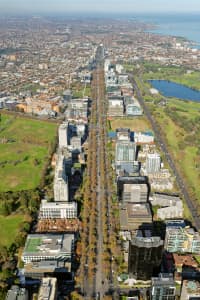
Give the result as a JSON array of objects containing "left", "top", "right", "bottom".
[{"left": 0, "top": 114, "right": 57, "bottom": 192}]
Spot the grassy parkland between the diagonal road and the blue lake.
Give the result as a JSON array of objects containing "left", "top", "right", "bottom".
[{"left": 145, "top": 92, "right": 200, "bottom": 203}]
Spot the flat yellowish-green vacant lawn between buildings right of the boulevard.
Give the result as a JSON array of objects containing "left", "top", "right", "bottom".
[{"left": 110, "top": 116, "right": 151, "bottom": 131}]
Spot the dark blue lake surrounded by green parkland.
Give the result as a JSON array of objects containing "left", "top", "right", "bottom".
[{"left": 149, "top": 80, "right": 200, "bottom": 102}]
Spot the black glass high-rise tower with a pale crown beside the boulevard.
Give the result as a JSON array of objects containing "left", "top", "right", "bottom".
[{"left": 128, "top": 236, "right": 163, "bottom": 280}]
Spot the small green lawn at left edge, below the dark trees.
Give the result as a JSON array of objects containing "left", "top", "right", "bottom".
[{"left": 0, "top": 215, "right": 25, "bottom": 247}]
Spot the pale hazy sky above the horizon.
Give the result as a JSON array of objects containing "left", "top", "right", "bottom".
[{"left": 0, "top": 0, "right": 200, "bottom": 14}]
